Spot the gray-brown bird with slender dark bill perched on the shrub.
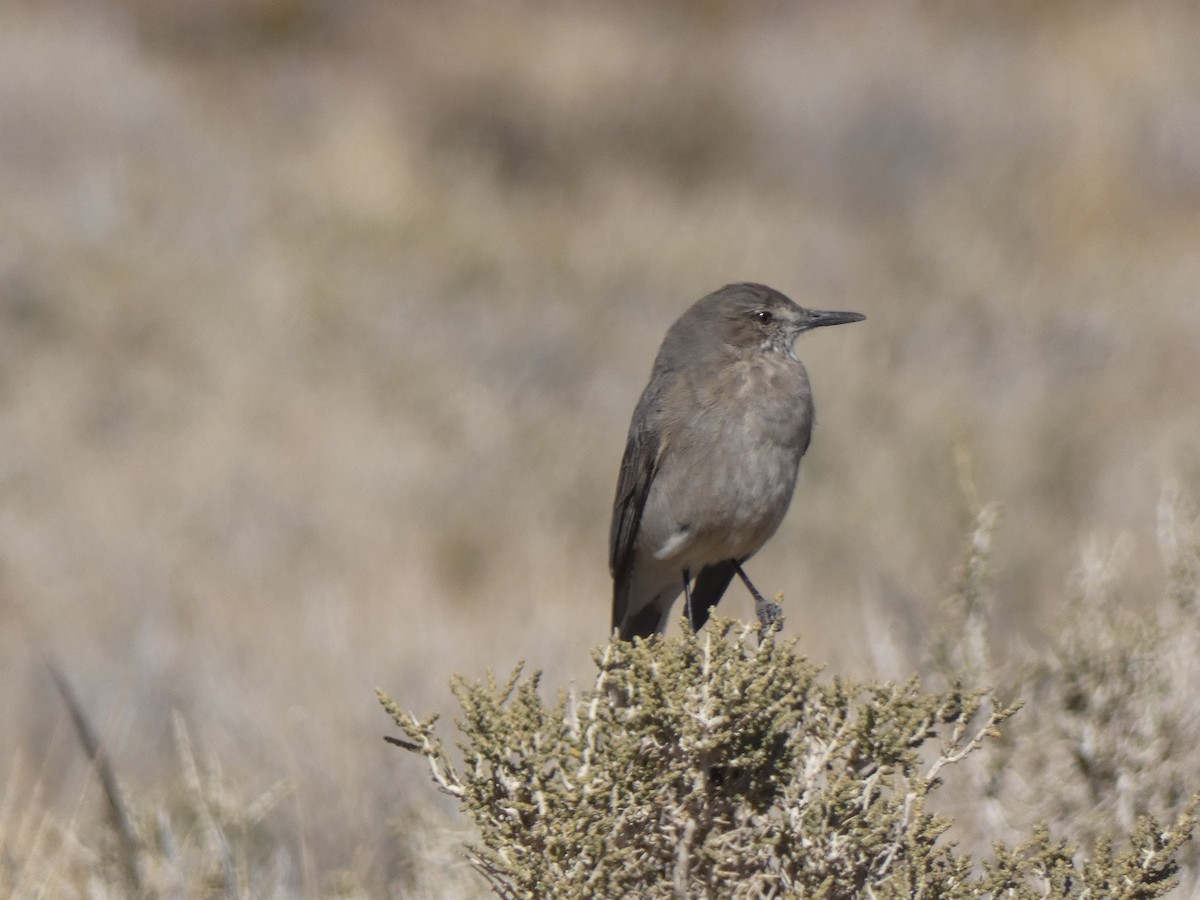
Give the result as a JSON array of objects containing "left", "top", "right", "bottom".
[{"left": 608, "top": 283, "right": 865, "bottom": 641}]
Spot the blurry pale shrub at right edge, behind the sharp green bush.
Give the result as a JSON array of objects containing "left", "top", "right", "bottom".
[{"left": 932, "top": 497, "right": 1200, "bottom": 883}]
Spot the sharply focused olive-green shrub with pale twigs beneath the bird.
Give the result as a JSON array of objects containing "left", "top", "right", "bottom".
[{"left": 380, "top": 620, "right": 1193, "bottom": 898}]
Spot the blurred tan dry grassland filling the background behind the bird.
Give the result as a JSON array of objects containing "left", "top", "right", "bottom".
[{"left": 0, "top": 0, "right": 1200, "bottom": 896}]
